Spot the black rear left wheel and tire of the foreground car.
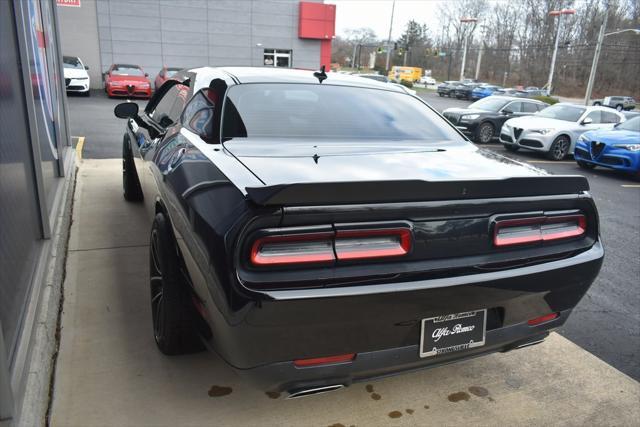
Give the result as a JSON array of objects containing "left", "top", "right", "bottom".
[{"left": 149, "top": 213, "right": 203, "bottom": 355}]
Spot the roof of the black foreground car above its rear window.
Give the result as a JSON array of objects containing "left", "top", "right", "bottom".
[{"left": 188, "top": 67, "right": 404, "bottom": 92}]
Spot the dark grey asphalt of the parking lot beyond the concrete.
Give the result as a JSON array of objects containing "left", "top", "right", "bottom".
[{"left": 69, "top": 91, "right": 640, "bottom": 380}]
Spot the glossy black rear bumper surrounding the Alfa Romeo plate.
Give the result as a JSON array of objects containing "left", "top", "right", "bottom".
[{"left": 208, "top": 241, "right": 604, "bottom": 390}]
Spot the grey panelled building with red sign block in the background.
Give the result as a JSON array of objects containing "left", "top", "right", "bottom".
[{"left": 57, "top": 0, "right": 336, "bottom": 88}]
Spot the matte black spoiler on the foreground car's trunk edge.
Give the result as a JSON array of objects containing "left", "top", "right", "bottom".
[{"left": 246, "top": 175, "right": 589, "bottom": 206}]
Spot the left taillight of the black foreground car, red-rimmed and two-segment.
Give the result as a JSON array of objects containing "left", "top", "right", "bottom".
[{"left": 250, "top": 228, "right": 412, "bottom": 266}]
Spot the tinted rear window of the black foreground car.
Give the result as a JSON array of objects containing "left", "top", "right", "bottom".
[{"left": 222, "top": 84, "right": 463, "bottom": 142}]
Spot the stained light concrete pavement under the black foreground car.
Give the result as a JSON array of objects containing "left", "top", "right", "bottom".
[{"left": 51, "top": 160, "right": 640, "bottom": 426}]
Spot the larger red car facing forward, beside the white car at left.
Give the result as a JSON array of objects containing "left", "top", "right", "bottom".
[{"left": 104, "top": 64, "right": 151, "bottom": 98}]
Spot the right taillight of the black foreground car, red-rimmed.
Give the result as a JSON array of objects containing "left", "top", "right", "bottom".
[{"left": 493, "top": 214, "right": 587, "bottom": 246}]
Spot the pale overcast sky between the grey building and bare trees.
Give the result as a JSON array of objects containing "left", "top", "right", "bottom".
[{"left": 325, "top": 0, "right": 452, "bottom": 39}]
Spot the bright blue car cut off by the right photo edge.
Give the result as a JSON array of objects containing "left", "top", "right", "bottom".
[{"left": 574, "top": 116, "right": 640, "bottom": 178}]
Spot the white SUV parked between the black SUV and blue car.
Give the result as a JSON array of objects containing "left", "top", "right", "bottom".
[{"left": 500, "top": 103, "right": 625, "bottom": 160}]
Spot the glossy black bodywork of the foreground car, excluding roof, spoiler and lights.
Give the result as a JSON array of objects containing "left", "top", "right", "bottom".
[{"left": 117, "top": 67, "right": 603, "bottom": 390}]
